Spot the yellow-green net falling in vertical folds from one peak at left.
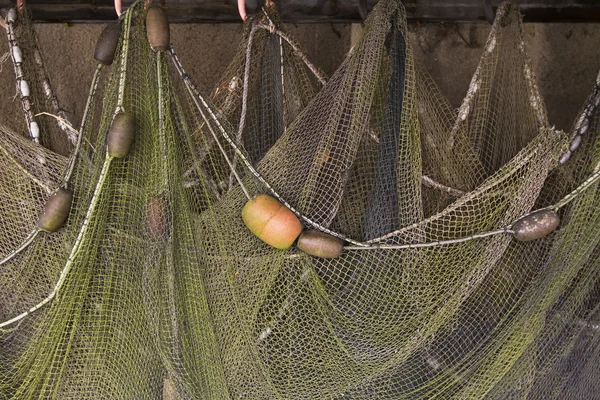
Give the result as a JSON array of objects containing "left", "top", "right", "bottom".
[{"left": 0, "top": 4, "right": 226, "bottom": 399}]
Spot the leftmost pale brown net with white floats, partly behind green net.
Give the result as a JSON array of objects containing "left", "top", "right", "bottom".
[{"left": 0, "top": 7, "right": 72, "bottom": 318}]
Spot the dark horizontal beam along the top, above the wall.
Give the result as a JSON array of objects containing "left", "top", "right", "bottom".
[{"left": 0, "top": 0, "right": 600, "bottom": 23}]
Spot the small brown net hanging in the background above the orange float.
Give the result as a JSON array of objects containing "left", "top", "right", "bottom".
[{"left": 193, "top": 2, "right": 326, "bottom": 202}]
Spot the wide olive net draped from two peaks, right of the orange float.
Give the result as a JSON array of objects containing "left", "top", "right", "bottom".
[{"left": 189, "top": 1, "right": 599, "bottom": 399}]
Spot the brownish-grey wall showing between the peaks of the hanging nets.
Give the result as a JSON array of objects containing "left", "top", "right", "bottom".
[{"left": 0, "top": 19, "right": 600, "bottom": 153}]
